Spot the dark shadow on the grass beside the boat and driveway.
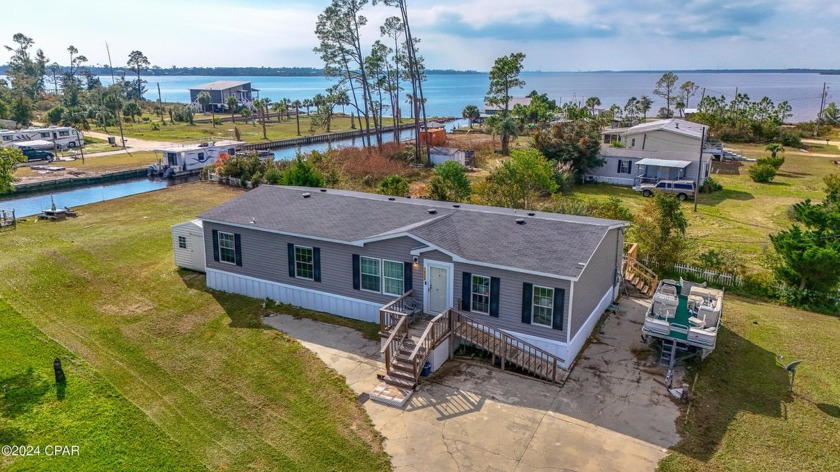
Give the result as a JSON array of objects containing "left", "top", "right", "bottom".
[{"left": 673, "top": 325, "right": 791, "bottom": 462}]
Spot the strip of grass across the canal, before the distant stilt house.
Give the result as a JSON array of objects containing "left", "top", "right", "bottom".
[{"left": 93, "top": 114, "right": 408, "bottom": 143}]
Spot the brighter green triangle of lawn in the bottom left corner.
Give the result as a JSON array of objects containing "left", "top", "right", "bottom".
[{"left": 0, "top": 301, "right": 203, "bottom": 470}]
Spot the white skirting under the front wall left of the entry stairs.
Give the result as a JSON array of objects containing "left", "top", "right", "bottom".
[{"left": 207, "top": 268, "right": 381, "bottom": 323}]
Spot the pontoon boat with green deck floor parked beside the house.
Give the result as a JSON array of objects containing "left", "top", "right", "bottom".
[{"left": 642, "top": 279, "right": 723, "bottom": 366}]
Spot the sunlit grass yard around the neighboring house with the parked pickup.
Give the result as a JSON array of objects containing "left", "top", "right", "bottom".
[{"left": 574, "top": 145, "right": 840, "bottom": 269}]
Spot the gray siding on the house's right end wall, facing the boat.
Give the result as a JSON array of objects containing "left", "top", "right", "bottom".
[{"left": 569, "top": 229, "right": 624, "bottom": 339}]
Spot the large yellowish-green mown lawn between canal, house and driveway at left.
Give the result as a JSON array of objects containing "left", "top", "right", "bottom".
[{"left": 0, "top": 183, "right": 390, "bottom": 471}]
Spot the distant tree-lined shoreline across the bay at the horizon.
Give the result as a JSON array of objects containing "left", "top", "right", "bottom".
[{"left": 0, "top": 65, "right": 840, "bottom": 78}]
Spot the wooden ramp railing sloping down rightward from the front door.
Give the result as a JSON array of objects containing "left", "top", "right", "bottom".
[{"left": 450, "top": 308, "right": 564, "bottom": 382}]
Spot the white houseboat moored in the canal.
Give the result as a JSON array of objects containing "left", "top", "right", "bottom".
[{"left": 147, "top": 140, "right": 245, "bottom": 178}]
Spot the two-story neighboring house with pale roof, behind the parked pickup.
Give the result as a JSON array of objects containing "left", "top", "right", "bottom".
[{"left": 585, "top": 118, "right": 715, "bottom": 185}]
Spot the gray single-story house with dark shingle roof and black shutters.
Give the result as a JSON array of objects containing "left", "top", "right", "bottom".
[{"left": 182, "top": 185, "right": 628, "bottom": 367}]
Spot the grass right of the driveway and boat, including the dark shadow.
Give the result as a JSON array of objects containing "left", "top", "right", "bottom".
[{"left": 660, "top": 296, "right": 840, "bottom": 472}]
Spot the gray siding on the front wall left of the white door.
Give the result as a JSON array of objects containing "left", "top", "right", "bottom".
[{"left": 204, "top": 221, "right": 422, "bottom": 305}]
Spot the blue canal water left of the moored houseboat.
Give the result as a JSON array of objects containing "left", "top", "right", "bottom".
[{"left": 0, "top": 179, "right": 174, "bottom": 218}]
